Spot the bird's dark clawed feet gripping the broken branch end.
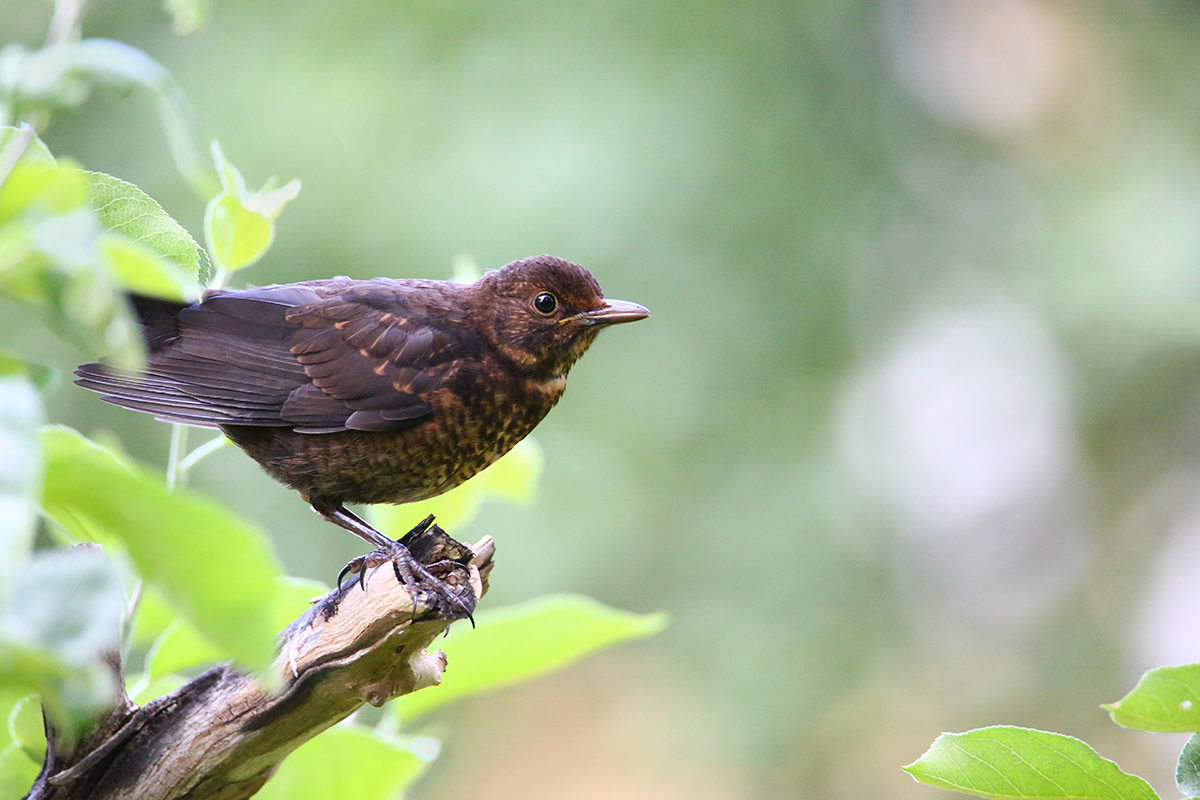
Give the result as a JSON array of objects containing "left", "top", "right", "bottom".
[{"left": 337, "top": 515, "right": 475, "bottom": 627}]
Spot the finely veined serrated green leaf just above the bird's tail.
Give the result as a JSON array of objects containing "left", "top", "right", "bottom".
[{"left": 86, "top": 173, "right": 203, "bottom": 286}]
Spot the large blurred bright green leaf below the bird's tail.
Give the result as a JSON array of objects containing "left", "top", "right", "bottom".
[{"left": 42, "top": 427, "right": 281, "bottom": 669}]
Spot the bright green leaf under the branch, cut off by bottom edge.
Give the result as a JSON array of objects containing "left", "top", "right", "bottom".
[{"left": 254, "top": 724, "right": 426, "bottom": 800}]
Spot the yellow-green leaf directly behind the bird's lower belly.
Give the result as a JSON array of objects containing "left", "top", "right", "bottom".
[{"left": 367, "top": 438, "right": 545, "bottom": 539}]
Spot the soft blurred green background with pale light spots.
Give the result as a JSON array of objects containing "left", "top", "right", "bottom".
[{"left": 7, "top": 0, "right": 1200, "bottom": 800}]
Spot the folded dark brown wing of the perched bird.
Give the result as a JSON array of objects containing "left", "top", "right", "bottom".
[{"left": 76, "top": 282, "right": 452, "bottom": 433}]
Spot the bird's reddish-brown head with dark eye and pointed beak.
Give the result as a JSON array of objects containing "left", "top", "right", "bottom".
[{"left": 472, "top": 255, "right": 650, "bottom": 379}]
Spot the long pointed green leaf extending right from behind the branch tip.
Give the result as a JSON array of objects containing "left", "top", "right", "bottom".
[{"left": 397, "top": 595, "right": 667, "bottom": 717}]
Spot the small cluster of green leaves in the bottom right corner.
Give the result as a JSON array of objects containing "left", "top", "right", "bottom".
[{"left": 905, "top": 664, "right": 1200, "bottom": 800}]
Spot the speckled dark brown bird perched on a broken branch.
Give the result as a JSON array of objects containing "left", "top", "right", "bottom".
[{"left": 76, "top": 255, "right": 649, "bottom": 606}]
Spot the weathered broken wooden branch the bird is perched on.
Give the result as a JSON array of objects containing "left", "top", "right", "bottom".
[{"left": 26, "top": 525, "right": 496, "bottom": 800}]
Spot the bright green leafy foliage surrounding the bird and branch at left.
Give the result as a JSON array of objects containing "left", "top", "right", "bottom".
[{"left": 0, "top": 0, "right": 664, "bottom": 799}]
